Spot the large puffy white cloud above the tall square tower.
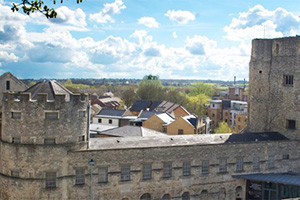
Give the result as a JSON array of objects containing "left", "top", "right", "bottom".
[{"left": 224, "top": 5, "right": 300, "bottom": 42}]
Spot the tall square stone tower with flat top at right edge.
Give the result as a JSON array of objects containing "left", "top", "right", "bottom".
[{"left": 249, "top": 36, "right": 300, "bottom": 139}]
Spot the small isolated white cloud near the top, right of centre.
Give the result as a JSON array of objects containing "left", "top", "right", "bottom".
[{"left": 165, "top": 10, "right": 195, "bottom": 24}]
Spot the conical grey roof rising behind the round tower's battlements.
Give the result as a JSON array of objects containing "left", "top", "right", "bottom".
[{"left": 24, "top": 80, "right": 72, "bottom": 100}]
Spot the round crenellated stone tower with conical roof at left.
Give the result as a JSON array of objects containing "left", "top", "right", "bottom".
[{"left": 0, "top": 81, "right": 88, "bottom": 199}]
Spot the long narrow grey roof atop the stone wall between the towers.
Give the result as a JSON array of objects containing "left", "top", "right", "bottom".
[{"left": 89, "top": 131, "right": 285, "bottom": 150}]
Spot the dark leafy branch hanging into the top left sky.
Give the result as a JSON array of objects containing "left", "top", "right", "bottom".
[{"left": 11, "top": 0, "right": 82, "bottom": 18}]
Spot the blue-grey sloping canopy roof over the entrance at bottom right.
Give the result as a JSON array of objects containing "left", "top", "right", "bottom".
[{"left": 232, "top": 173, "right": 300, "bottom": 186}]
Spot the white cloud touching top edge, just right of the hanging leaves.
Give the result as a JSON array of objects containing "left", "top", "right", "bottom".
[{"left": 90, "top": 0, "right": 126, "bottom": 24}]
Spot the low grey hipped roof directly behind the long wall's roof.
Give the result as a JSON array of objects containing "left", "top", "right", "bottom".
[{"left": 101, "top": 125, "right": 166, "bottom": 137}]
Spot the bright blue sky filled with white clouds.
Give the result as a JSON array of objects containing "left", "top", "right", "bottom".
[{"left": 0, "top": 0, "right": 300, "bottom": 81}]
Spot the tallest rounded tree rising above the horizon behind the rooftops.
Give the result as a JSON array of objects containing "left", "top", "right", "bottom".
[{"left": 137, "top": 75, "right": 164, "bottom": 100}]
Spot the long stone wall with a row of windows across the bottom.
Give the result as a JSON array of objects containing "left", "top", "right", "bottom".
[{"left": 0, "top": 138, "right": 300, "bottom": 200}]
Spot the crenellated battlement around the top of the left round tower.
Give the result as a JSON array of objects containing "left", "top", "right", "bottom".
[{"left": 3, "top": 92, "right": 88, "bottom": 103}]
